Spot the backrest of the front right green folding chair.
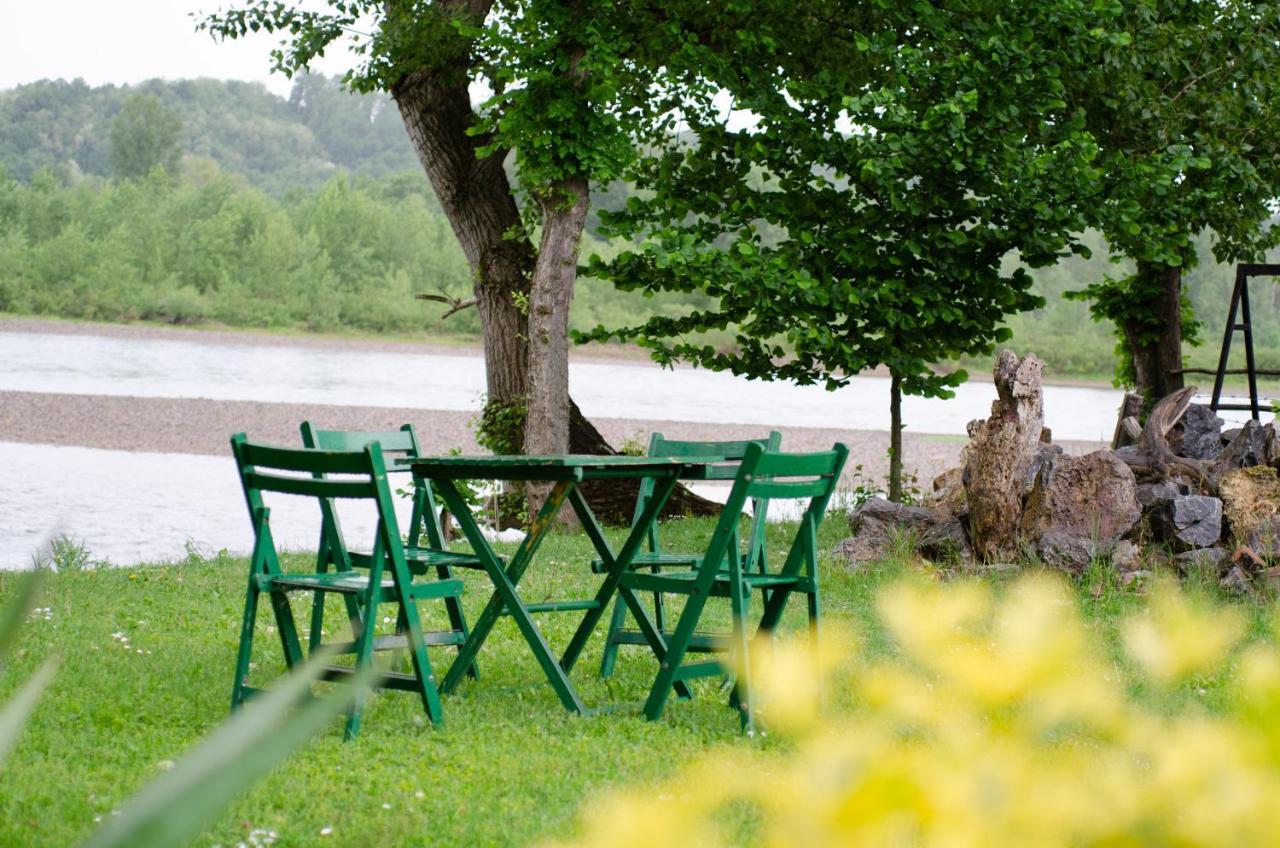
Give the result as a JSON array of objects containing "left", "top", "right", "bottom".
[{"left": 704, "top": 442, "right": 849, "bottom": 574}]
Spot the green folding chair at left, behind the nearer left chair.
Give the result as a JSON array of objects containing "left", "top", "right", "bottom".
[{"left": 301, "top": 421, "right": 484, "bottom": 678}]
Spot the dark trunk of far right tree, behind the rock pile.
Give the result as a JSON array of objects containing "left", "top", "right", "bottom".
[{"left": 1121, "top": 263, "right": 1184, "bottom": 402}]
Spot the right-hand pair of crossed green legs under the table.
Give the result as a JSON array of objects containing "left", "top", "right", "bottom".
[{"left": 561, "top": 477, "right": 690, "bottom": 697}]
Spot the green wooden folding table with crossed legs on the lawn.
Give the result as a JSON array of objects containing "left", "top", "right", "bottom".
[{"left": 404, "top": 455, "right": 719, "bottom": 715}]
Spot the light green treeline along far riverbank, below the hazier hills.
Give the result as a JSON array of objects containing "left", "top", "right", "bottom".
[{"left": 0, "top": 168, "right": 716, "bottom": 336}]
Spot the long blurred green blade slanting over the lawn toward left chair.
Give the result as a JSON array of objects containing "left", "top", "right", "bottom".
[{"left": 84, "top": 653, "right": 378, "bottom": 848}]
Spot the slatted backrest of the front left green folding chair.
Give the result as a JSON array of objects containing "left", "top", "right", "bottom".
[{"left": 232, "top": 433, "right": 403, "bottom": 578}]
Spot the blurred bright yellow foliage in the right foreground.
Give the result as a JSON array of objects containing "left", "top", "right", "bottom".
[{"left": 568, "top": 575, "right": 1280, "bottom": 848}]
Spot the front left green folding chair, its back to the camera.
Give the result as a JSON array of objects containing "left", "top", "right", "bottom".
[{"left": 232, "top": 433, "right": 462, "bottom": 739}]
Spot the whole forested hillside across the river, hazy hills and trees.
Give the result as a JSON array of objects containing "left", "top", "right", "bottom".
[{"left": 0, "top": 76, "right": 1280, "bottom": 377}]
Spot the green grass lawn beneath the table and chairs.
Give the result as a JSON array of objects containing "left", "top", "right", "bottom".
[{"left": 0, "top": 519, "right": 1270, "bottom": 845}]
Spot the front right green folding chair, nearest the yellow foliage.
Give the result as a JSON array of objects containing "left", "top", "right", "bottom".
[{"left": 621, "top": 444, "right": 849, "bottom": 733}]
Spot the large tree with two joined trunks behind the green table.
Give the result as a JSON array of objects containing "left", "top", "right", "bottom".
[{"left": 200, "top": 0, "right": 751, "bottom": 522}]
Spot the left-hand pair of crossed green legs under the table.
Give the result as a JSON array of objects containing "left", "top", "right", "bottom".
[{"left": 434, "top": 479, "right": 586, "bottom": 713}]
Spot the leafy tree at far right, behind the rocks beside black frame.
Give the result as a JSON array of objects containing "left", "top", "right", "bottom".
[{"left": 1068, "top": 0, "right": 1280, "bottom": 398}]
